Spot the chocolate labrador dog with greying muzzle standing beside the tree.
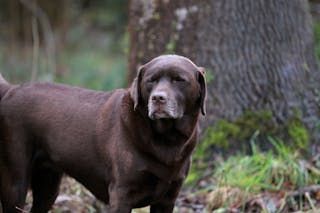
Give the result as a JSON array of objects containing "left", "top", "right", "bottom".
[{"left": 0, "top": 55, "right": 206, "bottom": 213}]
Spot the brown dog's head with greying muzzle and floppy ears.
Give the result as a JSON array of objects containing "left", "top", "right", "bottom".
[{"left": 131, "top": 55, "right": 206, "bottom": 120}]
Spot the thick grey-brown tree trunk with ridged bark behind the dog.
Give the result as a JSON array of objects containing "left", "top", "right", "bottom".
[{"left": 129, "top": 0, "right": 320, "bottom": 150}]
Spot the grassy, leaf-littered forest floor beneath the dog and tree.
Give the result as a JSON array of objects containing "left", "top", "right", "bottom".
[{"left": 26, "top": 149, "right": 320, "bottom": 213}]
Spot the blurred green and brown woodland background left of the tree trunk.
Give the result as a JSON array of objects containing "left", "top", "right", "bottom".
[{"left": 0, "top": 0, "right": 128, "bottom": 90}]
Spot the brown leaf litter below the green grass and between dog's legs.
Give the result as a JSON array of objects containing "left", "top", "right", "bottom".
[{"left": 41, "top": 178, "right": 320, "bottom": 213}]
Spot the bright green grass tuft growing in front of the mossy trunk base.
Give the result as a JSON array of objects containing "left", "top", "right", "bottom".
[{"left": 212, "top": 138, "right": 319, "bottom": 192}]
